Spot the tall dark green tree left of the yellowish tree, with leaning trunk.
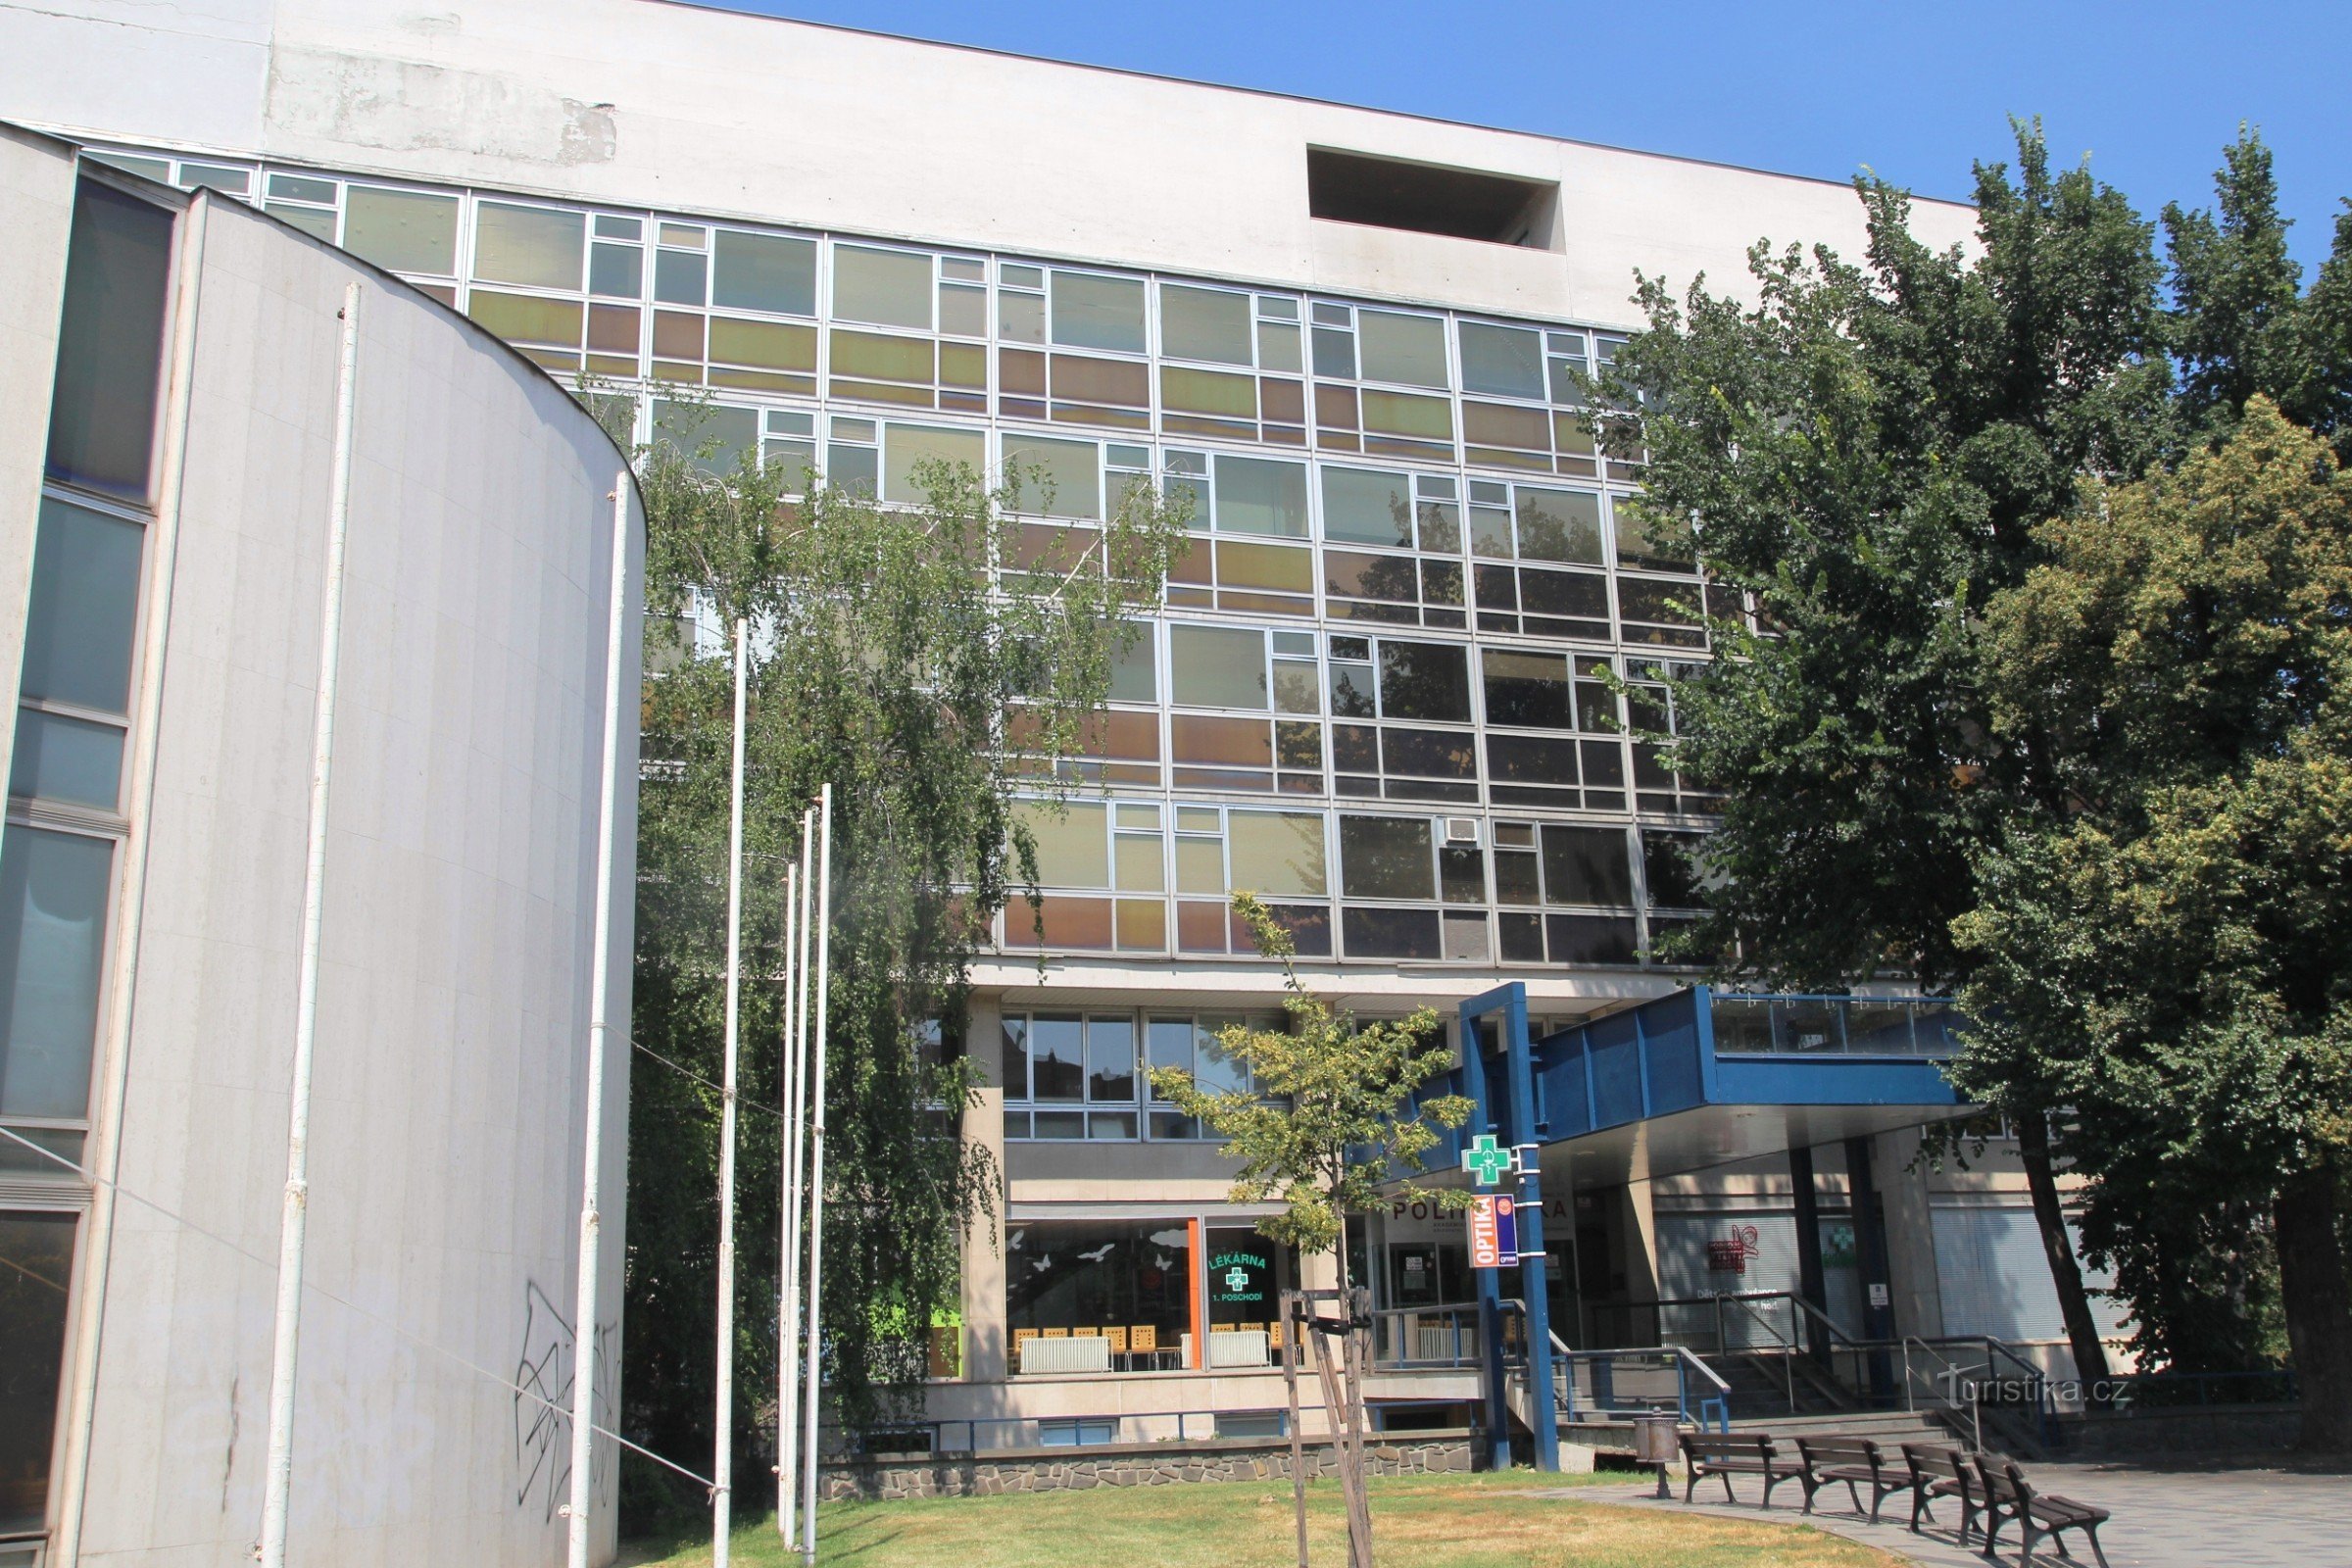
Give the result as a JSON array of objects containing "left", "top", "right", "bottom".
[{"left": 1597, "top": 124, "right": 2171, "bottom": 1400}]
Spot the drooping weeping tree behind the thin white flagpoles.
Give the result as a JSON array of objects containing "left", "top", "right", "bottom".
[{"left": 623, "top": 414, "right": 1183, "bottom": 1507}]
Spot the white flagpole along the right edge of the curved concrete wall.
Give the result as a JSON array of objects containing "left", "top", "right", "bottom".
[{"left": 566, "top": 467, "right": 628, "bottom": 1568}]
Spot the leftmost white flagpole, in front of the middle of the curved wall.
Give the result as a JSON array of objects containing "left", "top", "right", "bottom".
[{"left": 254, "top": 284, "right": 360, "bottom": 1568}]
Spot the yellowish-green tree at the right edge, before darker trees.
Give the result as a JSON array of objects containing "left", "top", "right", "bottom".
[{"left": 1954, "top": 395, "right": 2352, "bottom": 1450}]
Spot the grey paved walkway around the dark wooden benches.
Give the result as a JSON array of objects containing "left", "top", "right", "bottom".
[{"left": 1550, "top": 1462, "right": 2352, "bottom": 1568}]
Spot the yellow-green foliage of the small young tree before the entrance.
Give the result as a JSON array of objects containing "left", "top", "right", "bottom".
[{"left": 1152, "top": 894, "right": 1470, "bottom": 1284}]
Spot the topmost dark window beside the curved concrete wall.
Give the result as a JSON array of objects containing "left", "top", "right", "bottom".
[{"left": 49, "top": 178, "right": 172, "bottom": 501}]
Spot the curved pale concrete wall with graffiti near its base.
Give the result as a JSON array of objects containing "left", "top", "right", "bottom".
[{"left": 66, "top": 197, "right": 642, "bottom": 1568}]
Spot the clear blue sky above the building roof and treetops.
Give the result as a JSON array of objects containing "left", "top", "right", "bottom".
[{"left": 686, "top": 0, "right": 2352, "bottom": 268}]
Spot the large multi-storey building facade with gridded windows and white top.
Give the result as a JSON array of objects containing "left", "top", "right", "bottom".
[{"left": 0, "top": 0, "right": 2126, "bottom": 1523}]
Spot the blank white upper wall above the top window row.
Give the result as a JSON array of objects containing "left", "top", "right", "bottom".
[{"left": 0, "top": 0, "right": 1974, "bottom": 324}]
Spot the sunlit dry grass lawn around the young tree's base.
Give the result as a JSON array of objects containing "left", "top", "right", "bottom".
[{"left": 621, "top": 1469, "right": 1900, "bottom": 1568}]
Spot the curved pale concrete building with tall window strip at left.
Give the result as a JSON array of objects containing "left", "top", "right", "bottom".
[{"left": 0, "top": 116, "right": 642, "bottom": 1568}]
